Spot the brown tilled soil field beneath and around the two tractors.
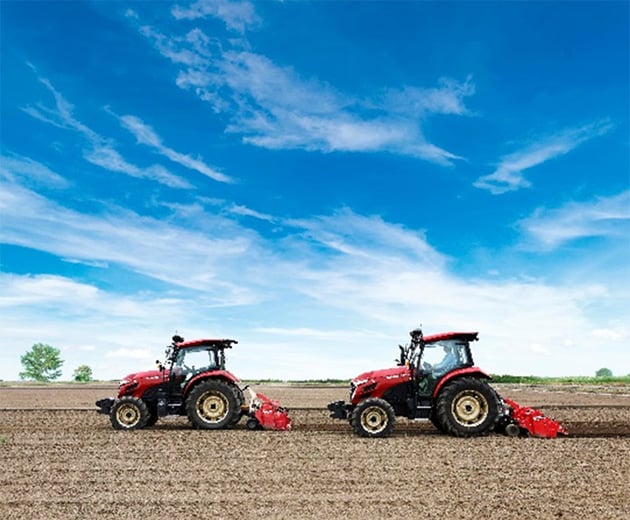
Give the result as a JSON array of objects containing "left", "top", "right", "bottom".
[{"left": 0, "top": 385, "right": 630, "bottom": 520}]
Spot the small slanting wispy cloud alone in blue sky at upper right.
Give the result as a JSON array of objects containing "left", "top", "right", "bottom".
[{"left": 474, "top": 120, "right": 613, "bottom": 195}]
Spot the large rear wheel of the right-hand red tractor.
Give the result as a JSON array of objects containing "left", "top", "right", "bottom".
[{"left": 436, "top": 377, "right": 499, "bottom": 437}]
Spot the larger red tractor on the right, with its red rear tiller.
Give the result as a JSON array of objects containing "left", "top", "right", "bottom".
[{"left": 328, "top": 329, "right": 567, "bottom": 437}]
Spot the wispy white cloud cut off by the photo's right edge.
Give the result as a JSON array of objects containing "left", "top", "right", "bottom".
[{"left": 519, "top": 191, "right": 630, "bottom": 249}]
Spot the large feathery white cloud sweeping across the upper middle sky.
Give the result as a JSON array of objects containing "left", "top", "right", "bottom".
[{"left": 132, "top": 17, "right": 475, "bottom": 166}]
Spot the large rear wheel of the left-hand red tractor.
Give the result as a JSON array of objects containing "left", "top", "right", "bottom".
[{"left": 186, "top": 379, "right": 240, "bottom": 430}]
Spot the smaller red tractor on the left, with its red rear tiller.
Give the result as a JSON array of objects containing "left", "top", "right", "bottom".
[{"left": 96, "top": 335, "right": 291, "bottom": 430}]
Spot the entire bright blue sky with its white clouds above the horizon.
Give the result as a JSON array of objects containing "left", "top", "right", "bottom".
[{"left": 0, "top": 1, "right": 630, "bottom": 380}]
